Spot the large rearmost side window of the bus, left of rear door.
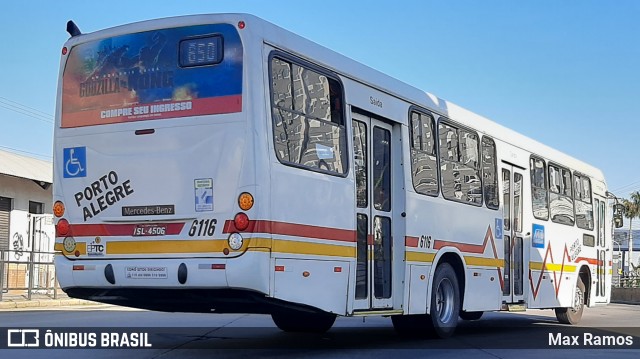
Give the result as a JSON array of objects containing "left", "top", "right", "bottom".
[{"left": 270, "top": 56, "right": 348, "bottom": 175}]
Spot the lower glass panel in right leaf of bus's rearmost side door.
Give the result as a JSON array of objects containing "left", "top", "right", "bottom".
[{"left": 373, "top": 216, "right": 391, "bottom": 299}]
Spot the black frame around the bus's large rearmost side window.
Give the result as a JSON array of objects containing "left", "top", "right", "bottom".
[{"left": 267, "top": 50, "right": 351, "bottom": 178}]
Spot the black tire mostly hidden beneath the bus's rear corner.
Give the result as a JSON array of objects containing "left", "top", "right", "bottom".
[{"left": 271, "top": 310, "right": 336, "bottom": 333}]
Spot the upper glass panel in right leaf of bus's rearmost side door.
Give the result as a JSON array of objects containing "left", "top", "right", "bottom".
[{"left": 373, "top": 126, "right": 391, "bottom": 212}]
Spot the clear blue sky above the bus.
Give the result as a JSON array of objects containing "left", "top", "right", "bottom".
[{"left": 0, "top": 0, "right": 640, "bottom": 197}]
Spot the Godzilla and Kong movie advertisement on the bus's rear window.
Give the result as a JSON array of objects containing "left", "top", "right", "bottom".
[{"left": 61, "top": 24, "right": 242, "bottom": 128}]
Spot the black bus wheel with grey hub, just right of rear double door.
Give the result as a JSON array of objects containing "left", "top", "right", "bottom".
[{"left": 429, "top": 263, "right": 460, "bottom": 338}]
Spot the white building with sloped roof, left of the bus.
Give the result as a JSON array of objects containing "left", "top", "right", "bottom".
[{"left": 0, "top": 150, "right": 55, "bottom": 287}]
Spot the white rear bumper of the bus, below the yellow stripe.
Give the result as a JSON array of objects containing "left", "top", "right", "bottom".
[{"left": 55, "top": 252, "right": 270, "bottom": 312}]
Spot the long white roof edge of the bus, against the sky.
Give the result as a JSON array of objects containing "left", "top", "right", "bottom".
[{"left": 61, "top": 13, "right": 605, "bottom": 183}]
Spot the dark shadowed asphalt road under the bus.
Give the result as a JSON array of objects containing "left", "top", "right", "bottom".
[{"left": 0, "top": 304, "right": 640, "bottom": 359}]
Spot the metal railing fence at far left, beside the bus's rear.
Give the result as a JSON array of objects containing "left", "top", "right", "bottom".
[{"left": 0, "top": 250, "right": 60, "bottom": 301}]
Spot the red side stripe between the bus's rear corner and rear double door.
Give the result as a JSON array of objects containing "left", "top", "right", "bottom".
[{"left": 222, "top": 220, "right": 356, "bottom": 242}]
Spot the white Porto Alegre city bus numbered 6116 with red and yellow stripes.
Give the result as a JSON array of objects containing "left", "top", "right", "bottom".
[{"left": 54, "top": 14, "right": 614, "bottom": 337}]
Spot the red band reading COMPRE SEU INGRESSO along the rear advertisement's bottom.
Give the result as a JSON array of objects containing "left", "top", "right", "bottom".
[{"left": 60, "top": 95, "right": 242, "bottom": 128}]
